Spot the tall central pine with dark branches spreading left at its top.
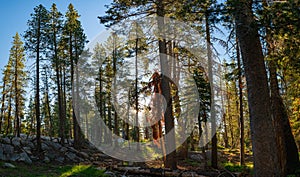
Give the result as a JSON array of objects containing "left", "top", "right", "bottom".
[{"left": 99, "top": 0, "right": 177, "bottom": 169}]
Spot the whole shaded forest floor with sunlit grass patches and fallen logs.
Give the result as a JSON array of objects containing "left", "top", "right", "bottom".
[{"left": 0, "top": 149, "right": 253, "bottom": 177}]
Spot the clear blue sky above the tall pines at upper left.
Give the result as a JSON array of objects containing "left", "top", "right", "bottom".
[{"left": 0, "top": 0, "right": 111, "bottom": 74}]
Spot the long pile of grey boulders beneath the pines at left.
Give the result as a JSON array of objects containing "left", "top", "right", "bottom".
[{"left": 0, "top": 135, "right": 99, "bottom": 165}]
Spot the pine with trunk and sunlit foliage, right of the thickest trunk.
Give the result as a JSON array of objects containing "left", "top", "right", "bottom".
[{"left": 261, "top": 1, "right": 300, "bottom": 175}]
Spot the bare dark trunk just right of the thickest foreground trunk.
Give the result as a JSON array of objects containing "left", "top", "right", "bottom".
[{"left": 263, "top": 0, "right": 300, "bottom": 172}]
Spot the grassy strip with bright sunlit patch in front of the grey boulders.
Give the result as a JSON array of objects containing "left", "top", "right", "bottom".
[{"left": 0, "top": 162, "right": 107, "bottom": 177}]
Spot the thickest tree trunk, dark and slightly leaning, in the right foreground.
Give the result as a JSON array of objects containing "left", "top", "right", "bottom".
[{"left": 234, "top": 0, "right": 282, "bottom": 176}]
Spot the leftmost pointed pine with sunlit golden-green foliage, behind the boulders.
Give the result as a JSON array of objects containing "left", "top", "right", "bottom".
[{"left": 0, "top": 33, "right": 27, "bottom": 135}]
